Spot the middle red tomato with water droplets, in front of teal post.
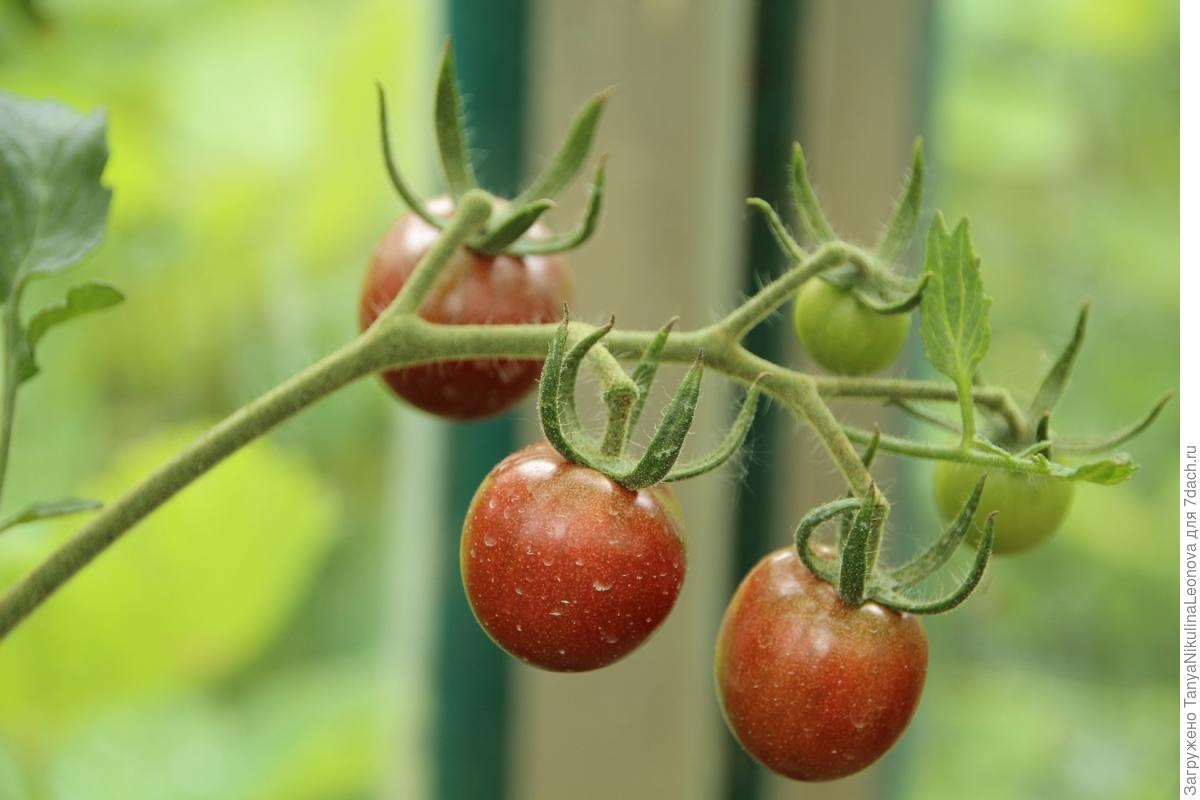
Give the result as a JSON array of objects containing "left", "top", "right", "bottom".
[{"left": 460, "top": 441, "right": 688, "bottom": 672}]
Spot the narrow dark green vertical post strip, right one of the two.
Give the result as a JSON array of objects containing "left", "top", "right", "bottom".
[{"left": 725, "top": 0, "right": 802, "bottom": 800}]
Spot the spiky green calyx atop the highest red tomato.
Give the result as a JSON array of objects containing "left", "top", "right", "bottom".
[{"left": 377, "top": 42, "right": 612, "bottom": 255}]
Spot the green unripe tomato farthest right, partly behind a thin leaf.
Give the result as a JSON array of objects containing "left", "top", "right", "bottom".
[{"left": 934, "top": 461, "right": 1075, "bottom": 555}]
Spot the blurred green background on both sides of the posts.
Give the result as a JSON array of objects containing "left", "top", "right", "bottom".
[{"left": 0, "top": 0, "right": 1180, "bottom": 800}]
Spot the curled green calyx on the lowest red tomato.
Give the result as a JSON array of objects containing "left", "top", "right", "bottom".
[{"left": 794, "top": 431, "right": 996, "bottom": 614}]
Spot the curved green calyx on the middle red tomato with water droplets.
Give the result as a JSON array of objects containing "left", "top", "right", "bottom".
[{"left": 538, "top": 307, "right": 760, "bottom": 491}]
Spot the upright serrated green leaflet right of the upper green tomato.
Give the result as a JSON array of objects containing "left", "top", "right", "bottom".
[{"left": 920, "top": 213, "right": 991, "bottom": 386}]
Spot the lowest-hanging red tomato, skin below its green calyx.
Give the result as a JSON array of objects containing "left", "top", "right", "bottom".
[{"left": 715, "top": 548, "right": 928, "bottom": 781}]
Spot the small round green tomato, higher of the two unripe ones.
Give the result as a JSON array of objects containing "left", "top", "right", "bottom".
[{"left": 792, "top": 278, "right": 912, "bottom": 375}]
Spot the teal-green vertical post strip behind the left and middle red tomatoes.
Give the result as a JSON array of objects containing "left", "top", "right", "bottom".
[{"left": 433, "top": 0, "right": 526, "bottom": 800}]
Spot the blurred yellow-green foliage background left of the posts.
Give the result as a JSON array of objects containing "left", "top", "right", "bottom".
[{"left": 0, "top": 0, "right": 436, "bottom": 800}]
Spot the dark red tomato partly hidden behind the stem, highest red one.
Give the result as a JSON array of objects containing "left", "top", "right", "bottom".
[{"left": 359, "top": 198, "right": 570, "bottom": 420}]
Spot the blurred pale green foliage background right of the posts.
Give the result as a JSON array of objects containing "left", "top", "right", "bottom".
[{"left": 902, "top": 0, "right": 1180, "bottom": 800}]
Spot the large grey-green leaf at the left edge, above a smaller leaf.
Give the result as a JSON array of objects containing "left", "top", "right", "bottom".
[{"left": 0, "top": 92, "right": 110, "bottom": 302}]
